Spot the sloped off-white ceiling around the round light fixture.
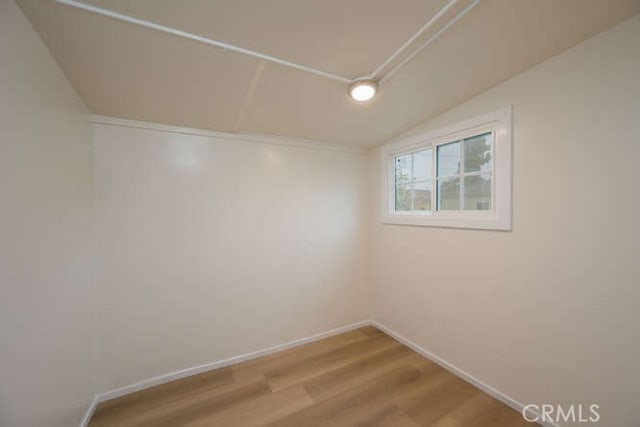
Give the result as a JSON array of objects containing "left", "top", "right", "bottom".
[{"left": 17, "top": 0, "right": 640, "bottom": 146}]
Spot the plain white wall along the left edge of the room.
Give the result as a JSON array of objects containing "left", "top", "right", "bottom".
[{"left": 0, "top": 1, "right": 94, "bottom": 427}]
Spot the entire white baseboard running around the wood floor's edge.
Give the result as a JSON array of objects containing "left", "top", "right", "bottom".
[{"left": 80, "top": 320, "right": 561, "bottom": 427}]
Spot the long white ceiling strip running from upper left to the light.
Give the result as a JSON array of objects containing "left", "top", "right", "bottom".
[{"left": 56, "top": 0, "right": 354, "bottom": 83}]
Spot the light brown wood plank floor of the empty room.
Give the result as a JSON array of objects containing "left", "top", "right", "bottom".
[{"left": 89, "top": 327, "right": 533, "bottom": 427}]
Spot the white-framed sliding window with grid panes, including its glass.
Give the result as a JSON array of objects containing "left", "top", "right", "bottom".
[{"left": 382, "top": 109, "right": 511, "bottom": 230}]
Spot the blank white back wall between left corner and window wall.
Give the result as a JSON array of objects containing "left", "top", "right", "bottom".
[{"left": 95, "top": 120, "right": 370, "bottom": 391}]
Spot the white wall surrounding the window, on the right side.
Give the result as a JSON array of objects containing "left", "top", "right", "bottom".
[{"left": 371, "top": 17, "right": 640, "bottom": 427}]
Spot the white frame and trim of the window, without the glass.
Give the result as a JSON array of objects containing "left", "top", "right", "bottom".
[{"left": 380, "top": 107, "right": 512, "bottom": 230}]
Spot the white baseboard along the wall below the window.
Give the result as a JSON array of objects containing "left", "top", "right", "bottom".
[{"left": 371, "top": 320, "right": 561, "bottom": 427}]
